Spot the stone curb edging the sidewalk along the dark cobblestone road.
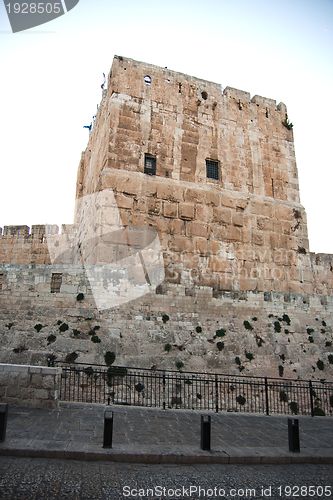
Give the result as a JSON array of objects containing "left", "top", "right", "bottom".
[{"left": 0, "top": 448, "right": 333, "bottom": 465}]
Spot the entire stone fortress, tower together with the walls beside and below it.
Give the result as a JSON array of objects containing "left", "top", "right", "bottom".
[{"left": 0, "top": 56, "right": 333, "bottom": 378}]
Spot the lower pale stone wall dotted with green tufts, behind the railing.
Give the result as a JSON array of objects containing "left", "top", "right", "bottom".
[{"left": 0, "top": 265, "right": 333, "bottom": 379}]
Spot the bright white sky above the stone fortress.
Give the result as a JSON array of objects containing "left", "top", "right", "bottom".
[{"left": 0, "top": 0, "right": 333, "bottom": 253}]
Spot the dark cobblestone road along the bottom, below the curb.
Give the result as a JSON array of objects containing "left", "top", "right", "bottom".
[{"left": 0, "top": 457, "right": 333, "bottom": 500}]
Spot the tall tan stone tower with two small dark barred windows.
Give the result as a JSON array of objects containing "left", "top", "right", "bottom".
[{"left": 77, "top": 56, "right": 333, "bottom": 296}]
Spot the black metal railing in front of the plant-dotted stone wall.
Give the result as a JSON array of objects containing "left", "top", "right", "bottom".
[{"left": 59, "top": 363, "right": 333, "bottom": 416}]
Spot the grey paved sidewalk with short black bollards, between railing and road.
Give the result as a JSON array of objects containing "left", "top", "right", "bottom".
[{"left": 0, "top": 403, "right": 333, "bottom": 464}]
